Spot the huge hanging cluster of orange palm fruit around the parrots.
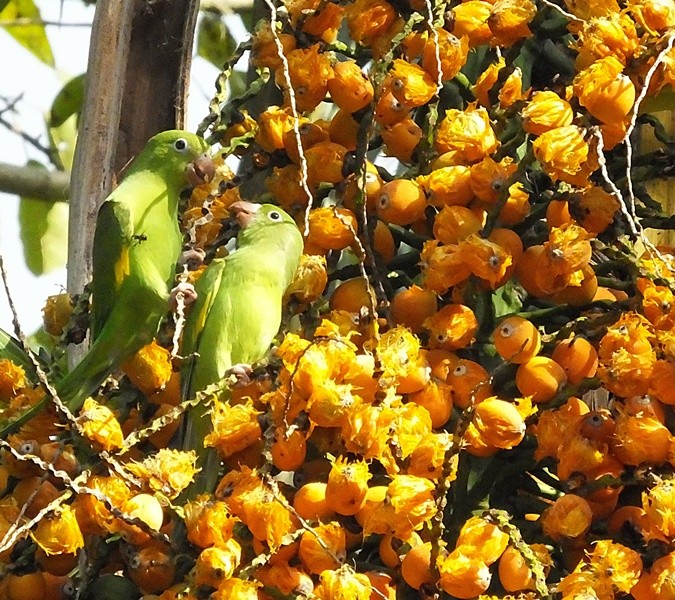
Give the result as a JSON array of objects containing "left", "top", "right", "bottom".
[{"left": 0, "top": 0, "right": 675, "bottom": 600}]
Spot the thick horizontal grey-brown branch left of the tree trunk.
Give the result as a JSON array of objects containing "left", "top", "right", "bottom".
[{"left": 0, "top": 162, "right": 70, "bottom": 202}]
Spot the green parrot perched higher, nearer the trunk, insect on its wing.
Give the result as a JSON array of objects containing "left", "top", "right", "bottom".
[{"left": 0, "top": 130, "right": 214, "bottom": 436}]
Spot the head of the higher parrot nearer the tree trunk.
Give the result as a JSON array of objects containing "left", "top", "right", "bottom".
[{"left": 134, "top": 129, "right": 215, "bottom": 186}]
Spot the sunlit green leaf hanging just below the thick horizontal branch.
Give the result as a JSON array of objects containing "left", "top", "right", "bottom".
[{"left": 19, "top": 163, "right": 68, "bottom": 275}]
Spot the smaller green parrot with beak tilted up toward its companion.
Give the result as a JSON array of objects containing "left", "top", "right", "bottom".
[{"left": 181, "top": 201, "right": 303, "bottom": 496}]
